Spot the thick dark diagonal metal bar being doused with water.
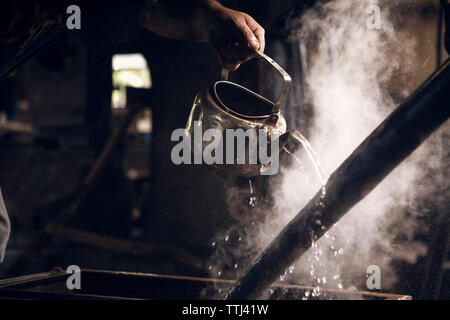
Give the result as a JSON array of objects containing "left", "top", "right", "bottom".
[{"left": 226, "top": 60, "right": 450, "bottom": 300}]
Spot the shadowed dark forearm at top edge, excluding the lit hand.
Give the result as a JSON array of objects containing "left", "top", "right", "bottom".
[{"left": 137, "top": 0, "right": 224, "bottom": 41}]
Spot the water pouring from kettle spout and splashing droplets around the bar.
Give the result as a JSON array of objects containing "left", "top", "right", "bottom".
[{"left": 202, "top": 128, "right": 334, "bottom": 299}]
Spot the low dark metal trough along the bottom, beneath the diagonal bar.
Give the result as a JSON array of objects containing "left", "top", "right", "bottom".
[{"left": 0, "top": 268, "right": 411, "bottom": 300}]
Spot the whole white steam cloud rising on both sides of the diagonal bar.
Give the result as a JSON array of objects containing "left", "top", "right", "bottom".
[{"left": 206, "top": 0, "right": 445, "bottom": 298}]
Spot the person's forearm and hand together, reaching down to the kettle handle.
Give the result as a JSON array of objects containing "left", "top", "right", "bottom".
[{"left": 139, "top": 0, "right": 265, "bottom": 70}]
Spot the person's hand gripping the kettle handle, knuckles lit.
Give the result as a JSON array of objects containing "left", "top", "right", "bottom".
[{"left": 208, "top": 6, "right": 265, "bottom": 71}]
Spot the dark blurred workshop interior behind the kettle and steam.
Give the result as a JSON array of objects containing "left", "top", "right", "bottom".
[{"left": 0, "top": 0, "right": 450, "bottom": 298}]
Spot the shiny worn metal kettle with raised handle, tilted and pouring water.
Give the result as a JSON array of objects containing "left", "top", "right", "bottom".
[{"left": 185, "top": 51, "right": 291, "bottom": 178}]
